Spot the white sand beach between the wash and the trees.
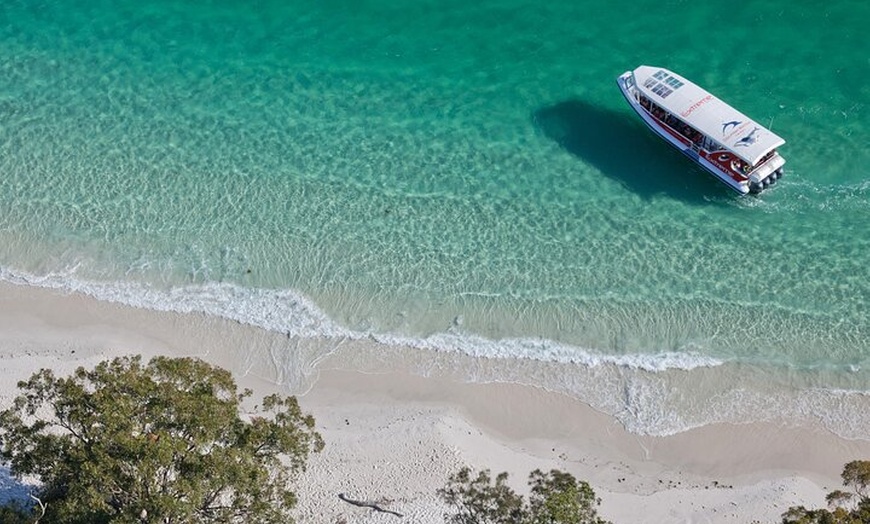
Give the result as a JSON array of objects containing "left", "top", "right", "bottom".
[{"left": 0, "top": 284, "right": 870, "bottom": 524}]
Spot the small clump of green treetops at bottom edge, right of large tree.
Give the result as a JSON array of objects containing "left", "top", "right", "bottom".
[{"left": 438, "top": 467, "right": 607, "bottom": 524}]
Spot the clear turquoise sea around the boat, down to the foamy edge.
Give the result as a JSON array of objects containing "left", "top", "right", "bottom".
[{"left": 0, "top": 0, "right": 870, "bottom": 432}]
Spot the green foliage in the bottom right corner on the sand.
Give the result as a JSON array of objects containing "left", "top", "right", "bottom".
[{"left": 782, "top": 460, "right": 870, "bottom": 524}]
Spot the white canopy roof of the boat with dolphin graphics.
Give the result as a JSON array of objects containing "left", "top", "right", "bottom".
[{"left": 634, "top": 66, "right": 785, "bottom": 165}]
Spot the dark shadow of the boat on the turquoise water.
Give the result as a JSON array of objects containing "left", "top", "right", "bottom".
[{"left": 533, "top": 100, "right": 730, "bottom": 204}]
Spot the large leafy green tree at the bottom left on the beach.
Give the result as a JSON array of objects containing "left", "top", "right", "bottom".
[{"left": 0, "top": 356, "right": 323, "bottom": 524}]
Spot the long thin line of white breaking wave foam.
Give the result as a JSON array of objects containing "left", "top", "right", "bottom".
[{"left": 0, "top": 267, "right": 722, "bottom": 372}]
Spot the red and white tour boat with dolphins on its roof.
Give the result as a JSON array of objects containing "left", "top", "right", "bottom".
[{"left": 617, "top": 65, "right": 785, "bottom": 195}]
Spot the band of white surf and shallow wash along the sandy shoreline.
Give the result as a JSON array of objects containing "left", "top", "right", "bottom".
[{"left": 0, "top": 268, "right": 870, "bottom": 439}]
